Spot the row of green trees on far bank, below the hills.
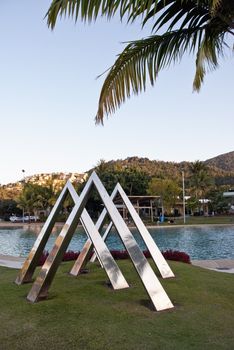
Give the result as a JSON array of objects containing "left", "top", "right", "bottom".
[{"left": 0, "top": 160, "right": 231, "bottom": 219}]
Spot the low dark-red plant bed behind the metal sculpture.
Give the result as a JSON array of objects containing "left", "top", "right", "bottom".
[{"left": 38, "top": 249, "right": 191, "bottom": 266}]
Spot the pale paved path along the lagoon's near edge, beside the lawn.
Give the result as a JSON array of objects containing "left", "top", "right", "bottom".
[{"left": 0, "top": 254, "right": 234, "bottom": 273}]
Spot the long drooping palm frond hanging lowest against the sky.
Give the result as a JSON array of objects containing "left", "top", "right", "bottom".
[{"left": 96, "top": 27, "right": 204, "bottom": 123}]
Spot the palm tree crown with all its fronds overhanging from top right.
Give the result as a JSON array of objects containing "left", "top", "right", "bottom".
[{"left": 47, "top": 0, "right": 234, "bottom": 123}]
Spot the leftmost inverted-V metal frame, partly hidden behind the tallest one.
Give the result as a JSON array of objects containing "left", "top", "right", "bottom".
[{"left": 15, "top": 181, "right": 129, "bottom": 289}]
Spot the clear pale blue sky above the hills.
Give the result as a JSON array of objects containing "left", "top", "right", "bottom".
[{"left": 0, "top": 0, "right": 234, "bottom": 184}]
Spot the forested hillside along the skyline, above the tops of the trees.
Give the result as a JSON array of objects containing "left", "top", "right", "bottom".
[{"left": 0, "top": 151, "right": 234, "bottom": 200}]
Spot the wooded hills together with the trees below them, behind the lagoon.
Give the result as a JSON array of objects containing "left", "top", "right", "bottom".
[{"left": 0, "top": 152, "right": 234, "bottom": 217}]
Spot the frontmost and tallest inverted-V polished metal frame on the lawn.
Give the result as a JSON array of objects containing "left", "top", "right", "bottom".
[{"left": 16, "top": 172, "right": 173, "bottom": 311}]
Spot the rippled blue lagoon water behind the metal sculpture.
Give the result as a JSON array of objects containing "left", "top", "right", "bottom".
[{"left": 0, "top": 225, "right": 234, "bottom": 260}]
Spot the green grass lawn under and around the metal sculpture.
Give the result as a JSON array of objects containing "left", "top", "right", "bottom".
[{"left": 0, "top": 260, "right": 234, "bottom": 350}]
